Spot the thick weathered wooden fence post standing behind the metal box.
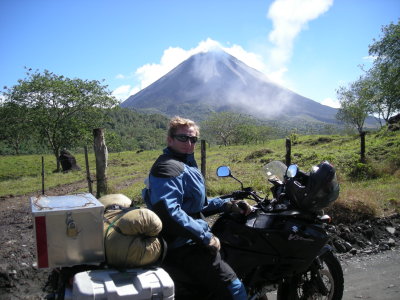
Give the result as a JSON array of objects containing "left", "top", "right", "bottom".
[{"left": 93, "top": 128, "right": 108, "bottom": 198}]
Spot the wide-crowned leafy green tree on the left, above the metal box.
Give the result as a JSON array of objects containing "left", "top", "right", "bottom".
[{"left": 4, "top": 69, "right": 117, "bottom": 171}]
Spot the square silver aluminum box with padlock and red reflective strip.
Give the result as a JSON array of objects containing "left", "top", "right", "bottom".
[{"left": 30, "top": 194, "right": 105, "bottom": 268}]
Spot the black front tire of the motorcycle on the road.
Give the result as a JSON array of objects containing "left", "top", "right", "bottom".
[{"left": 277, "top": 251, "right": 344, "bottom": 300}]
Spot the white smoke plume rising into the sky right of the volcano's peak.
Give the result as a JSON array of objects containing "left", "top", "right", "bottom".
[{"left": 267, "top": 0, "right": 333, "bottom": 82}]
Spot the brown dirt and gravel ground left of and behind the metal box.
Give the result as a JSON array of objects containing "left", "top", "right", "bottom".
[{"left": 0, "top": 182, "right": 86, "bottom": 300}]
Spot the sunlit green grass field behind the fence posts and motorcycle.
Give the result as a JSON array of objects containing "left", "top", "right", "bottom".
[{"left": 0, "top": 130, "right": 400, "bottom": 217}]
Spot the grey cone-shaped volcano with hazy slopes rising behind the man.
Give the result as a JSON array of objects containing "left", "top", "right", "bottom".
[{"left": 121, "top": 50, "right": 338, "bottom": 124}]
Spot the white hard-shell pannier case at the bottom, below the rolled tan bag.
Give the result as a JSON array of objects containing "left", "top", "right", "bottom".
[{"left": 72, "top": 268, "right": 174, "bottom": 300}]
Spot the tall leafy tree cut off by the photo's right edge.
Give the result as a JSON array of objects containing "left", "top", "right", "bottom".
[{"left": 368, "top": 20, "right": 400, "bottom": 121}]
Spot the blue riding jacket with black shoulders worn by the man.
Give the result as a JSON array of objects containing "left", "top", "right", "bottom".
[{"left": 143, "top": 148, "right": 228, "bottom": 249}]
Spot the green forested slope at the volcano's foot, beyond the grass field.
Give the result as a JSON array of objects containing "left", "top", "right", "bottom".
[{"left": 0, "top": 107, "right": 352, "bottom": 155}]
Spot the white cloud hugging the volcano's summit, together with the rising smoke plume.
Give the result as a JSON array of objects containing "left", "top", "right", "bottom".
[{"left": 113, "top": 0, "right": 333, "bottom": 100}]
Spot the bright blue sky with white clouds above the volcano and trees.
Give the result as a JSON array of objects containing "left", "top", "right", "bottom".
[{"left": 0, "top": 0, "right": 400, "bottom": 106}]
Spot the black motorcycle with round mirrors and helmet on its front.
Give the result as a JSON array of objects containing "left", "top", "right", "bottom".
[{"left": 175, "top": 161, "right": 344, "bottom": 300}]
